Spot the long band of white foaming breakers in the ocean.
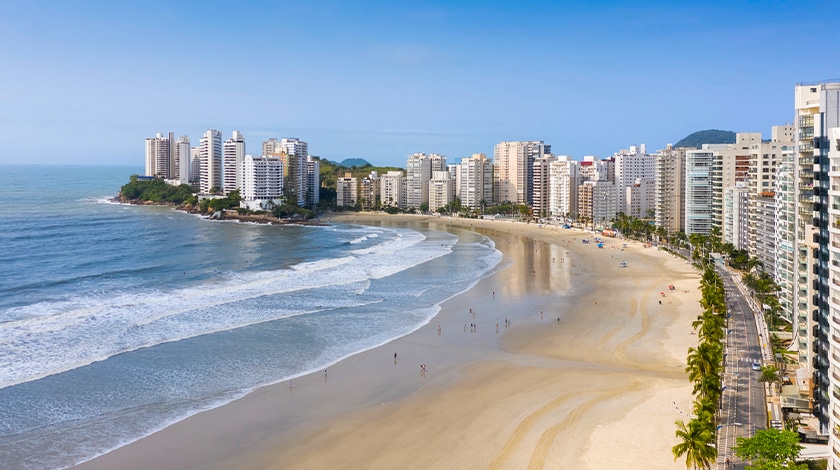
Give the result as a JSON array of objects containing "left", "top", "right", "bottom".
[{"left": 0, "top": 229, "right": 455, "bottom": 388}]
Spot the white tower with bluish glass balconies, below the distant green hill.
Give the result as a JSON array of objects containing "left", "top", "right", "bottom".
[{"left": 684, "top": 149, "right": 722, "bottom": 235}]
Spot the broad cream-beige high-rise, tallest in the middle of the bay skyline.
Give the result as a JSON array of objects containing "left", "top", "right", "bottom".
[{"left": 493, "top": 141, "right": 551, "bottom": 205}]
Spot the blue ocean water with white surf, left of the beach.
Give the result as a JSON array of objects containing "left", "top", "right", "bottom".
[{"left": 0, "top": 166, "right": 501, "bottom": 469}]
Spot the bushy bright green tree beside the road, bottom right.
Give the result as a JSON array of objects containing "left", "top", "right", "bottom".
[{"left": 734, "top": 429, "right": 808, "bottom": 470}]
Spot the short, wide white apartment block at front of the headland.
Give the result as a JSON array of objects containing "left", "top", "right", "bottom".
[{"left": 240, "top": 155, "right": 283, "bottom": 210}]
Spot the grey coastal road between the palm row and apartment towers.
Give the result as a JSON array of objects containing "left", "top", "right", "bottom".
[{"left": 717, "top": 266, "right": 767, "bottom": 469}]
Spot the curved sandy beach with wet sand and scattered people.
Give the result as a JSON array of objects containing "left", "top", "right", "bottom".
[{"left": 77, "top": 214, "right": 700, "bottom": 469}]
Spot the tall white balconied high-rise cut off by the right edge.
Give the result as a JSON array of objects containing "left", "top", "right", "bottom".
[{"left": 794, "top": 82, "right": 840, "bottom": 448}]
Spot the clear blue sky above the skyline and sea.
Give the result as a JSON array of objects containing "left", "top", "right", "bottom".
[{"left": 0, "top": 0, "right": 840, "bottom": 166}]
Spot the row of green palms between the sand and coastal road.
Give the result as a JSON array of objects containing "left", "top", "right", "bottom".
[{"left": 671, "top": 265, "right": 726, "bottom": 468}]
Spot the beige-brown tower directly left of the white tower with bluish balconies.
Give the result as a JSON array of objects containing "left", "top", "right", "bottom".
[{"left": 654, "top": 144, "right": 687, "bottom": 233}]
